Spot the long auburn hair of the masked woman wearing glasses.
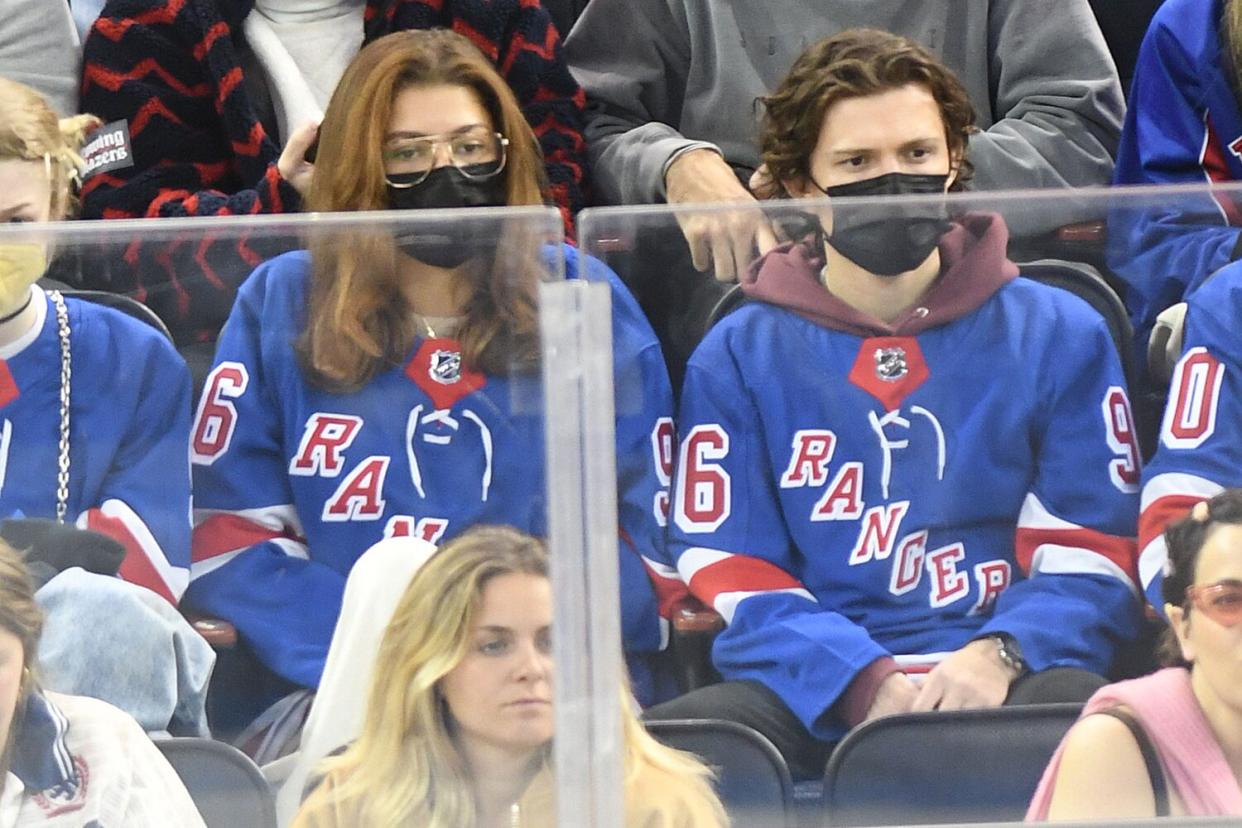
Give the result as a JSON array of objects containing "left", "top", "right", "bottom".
[{"left": 297, "top": 30, "right": 544, "bottom": 391}]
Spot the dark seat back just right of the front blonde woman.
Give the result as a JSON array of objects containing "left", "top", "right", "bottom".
[{"left": 646, "top": 719, "right": 795, "bottom": 828}]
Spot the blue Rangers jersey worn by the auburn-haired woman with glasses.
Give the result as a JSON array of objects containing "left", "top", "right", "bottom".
[{"left": 186, "top": 246, "right": 678, "bottom": 688}]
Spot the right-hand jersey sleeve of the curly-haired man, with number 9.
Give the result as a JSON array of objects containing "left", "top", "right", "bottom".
[{"left": 979, "top": 299, "right": 1140, "bottom": 674}]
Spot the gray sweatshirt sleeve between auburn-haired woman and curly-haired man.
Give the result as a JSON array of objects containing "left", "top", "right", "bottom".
[{"left": 565, "top": 0, "right": 712, "bottom": 204}]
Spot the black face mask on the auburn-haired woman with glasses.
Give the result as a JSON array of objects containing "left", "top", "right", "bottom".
[{"left": 389, "top": 164, "right": 507, "bottom": 269}]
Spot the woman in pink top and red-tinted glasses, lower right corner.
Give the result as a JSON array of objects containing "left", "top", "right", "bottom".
[{"left": 1027, "top": 489, "right": 1242, "bottom": 821}]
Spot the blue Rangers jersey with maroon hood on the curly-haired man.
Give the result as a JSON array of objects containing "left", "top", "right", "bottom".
[{"left": 669, "top": 216, "right": 1139, "bottom": 740}]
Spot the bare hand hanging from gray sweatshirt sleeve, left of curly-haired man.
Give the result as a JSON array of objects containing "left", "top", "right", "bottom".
[{"left": 664, "top": 149, "right": 776, "bottom": 282}]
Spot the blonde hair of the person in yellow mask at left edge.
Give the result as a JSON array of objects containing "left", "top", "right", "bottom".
[{"left": 0, "top": 78, "right": 103, "bottom": 221}]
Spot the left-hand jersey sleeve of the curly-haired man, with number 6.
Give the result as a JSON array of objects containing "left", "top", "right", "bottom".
[{"left": 669, "top": 340, "right": 888, "bottom": 739}]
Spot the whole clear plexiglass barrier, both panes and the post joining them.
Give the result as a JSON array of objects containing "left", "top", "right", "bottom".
[{"left": 0, "top": 189, "right": 1242, "bottom": 828}]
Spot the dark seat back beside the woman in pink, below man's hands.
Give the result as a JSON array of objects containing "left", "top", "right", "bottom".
[{"left": 823, "top": 704, "right": 1082, "bottom": 827}]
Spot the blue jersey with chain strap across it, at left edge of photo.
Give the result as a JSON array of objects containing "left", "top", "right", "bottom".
[{"left": 0, "top": 287, "right": 190, "bottom": 603}]
